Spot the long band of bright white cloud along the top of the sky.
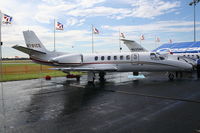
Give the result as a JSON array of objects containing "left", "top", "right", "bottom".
[{"left": 35, "top": 0, "right": 180, "bottom": 25}]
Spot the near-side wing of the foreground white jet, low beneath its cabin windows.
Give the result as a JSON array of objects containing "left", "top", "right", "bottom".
[{"left": 50, "top": 64, "right": 117, "bottom": 72}]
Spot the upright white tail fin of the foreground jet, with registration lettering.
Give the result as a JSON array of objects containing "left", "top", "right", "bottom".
[{"left": 23, "top": 30, "right": 47, "bottom": 53}]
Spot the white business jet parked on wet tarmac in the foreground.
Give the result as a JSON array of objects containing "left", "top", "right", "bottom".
[{"left": 13, "top": 31, "right": 192, "bottom": 83}]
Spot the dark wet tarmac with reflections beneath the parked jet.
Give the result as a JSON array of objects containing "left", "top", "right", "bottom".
[{"left": 0, "top": 73, "right": 200, "bottom": 133}]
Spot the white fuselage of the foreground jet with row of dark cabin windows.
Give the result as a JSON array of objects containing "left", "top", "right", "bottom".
[{"left": 30, "top": 52, "right": 192, "bottom": 72}]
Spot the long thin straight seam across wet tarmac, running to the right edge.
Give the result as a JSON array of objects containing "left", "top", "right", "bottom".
[{"left": 106, "top": 90, "right": 200, "bottom": 104}]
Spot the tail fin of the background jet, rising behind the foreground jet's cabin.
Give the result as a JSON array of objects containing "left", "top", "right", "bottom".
[{"left": 121, "top": 39, "right": 148, "bottom": 52}]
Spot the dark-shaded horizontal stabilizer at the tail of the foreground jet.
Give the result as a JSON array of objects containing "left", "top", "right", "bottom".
[{"left": 12, "top": 45, "right": 46, "bottom": 55}]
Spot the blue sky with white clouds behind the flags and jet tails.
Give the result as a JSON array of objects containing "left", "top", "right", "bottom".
[{"left": 0, "top": 0, "right": 200, "bottom": 57}]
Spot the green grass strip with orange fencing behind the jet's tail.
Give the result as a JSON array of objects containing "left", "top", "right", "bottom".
[{"left": 0, "top": 61, "right": 84, "bottom": 82}]
